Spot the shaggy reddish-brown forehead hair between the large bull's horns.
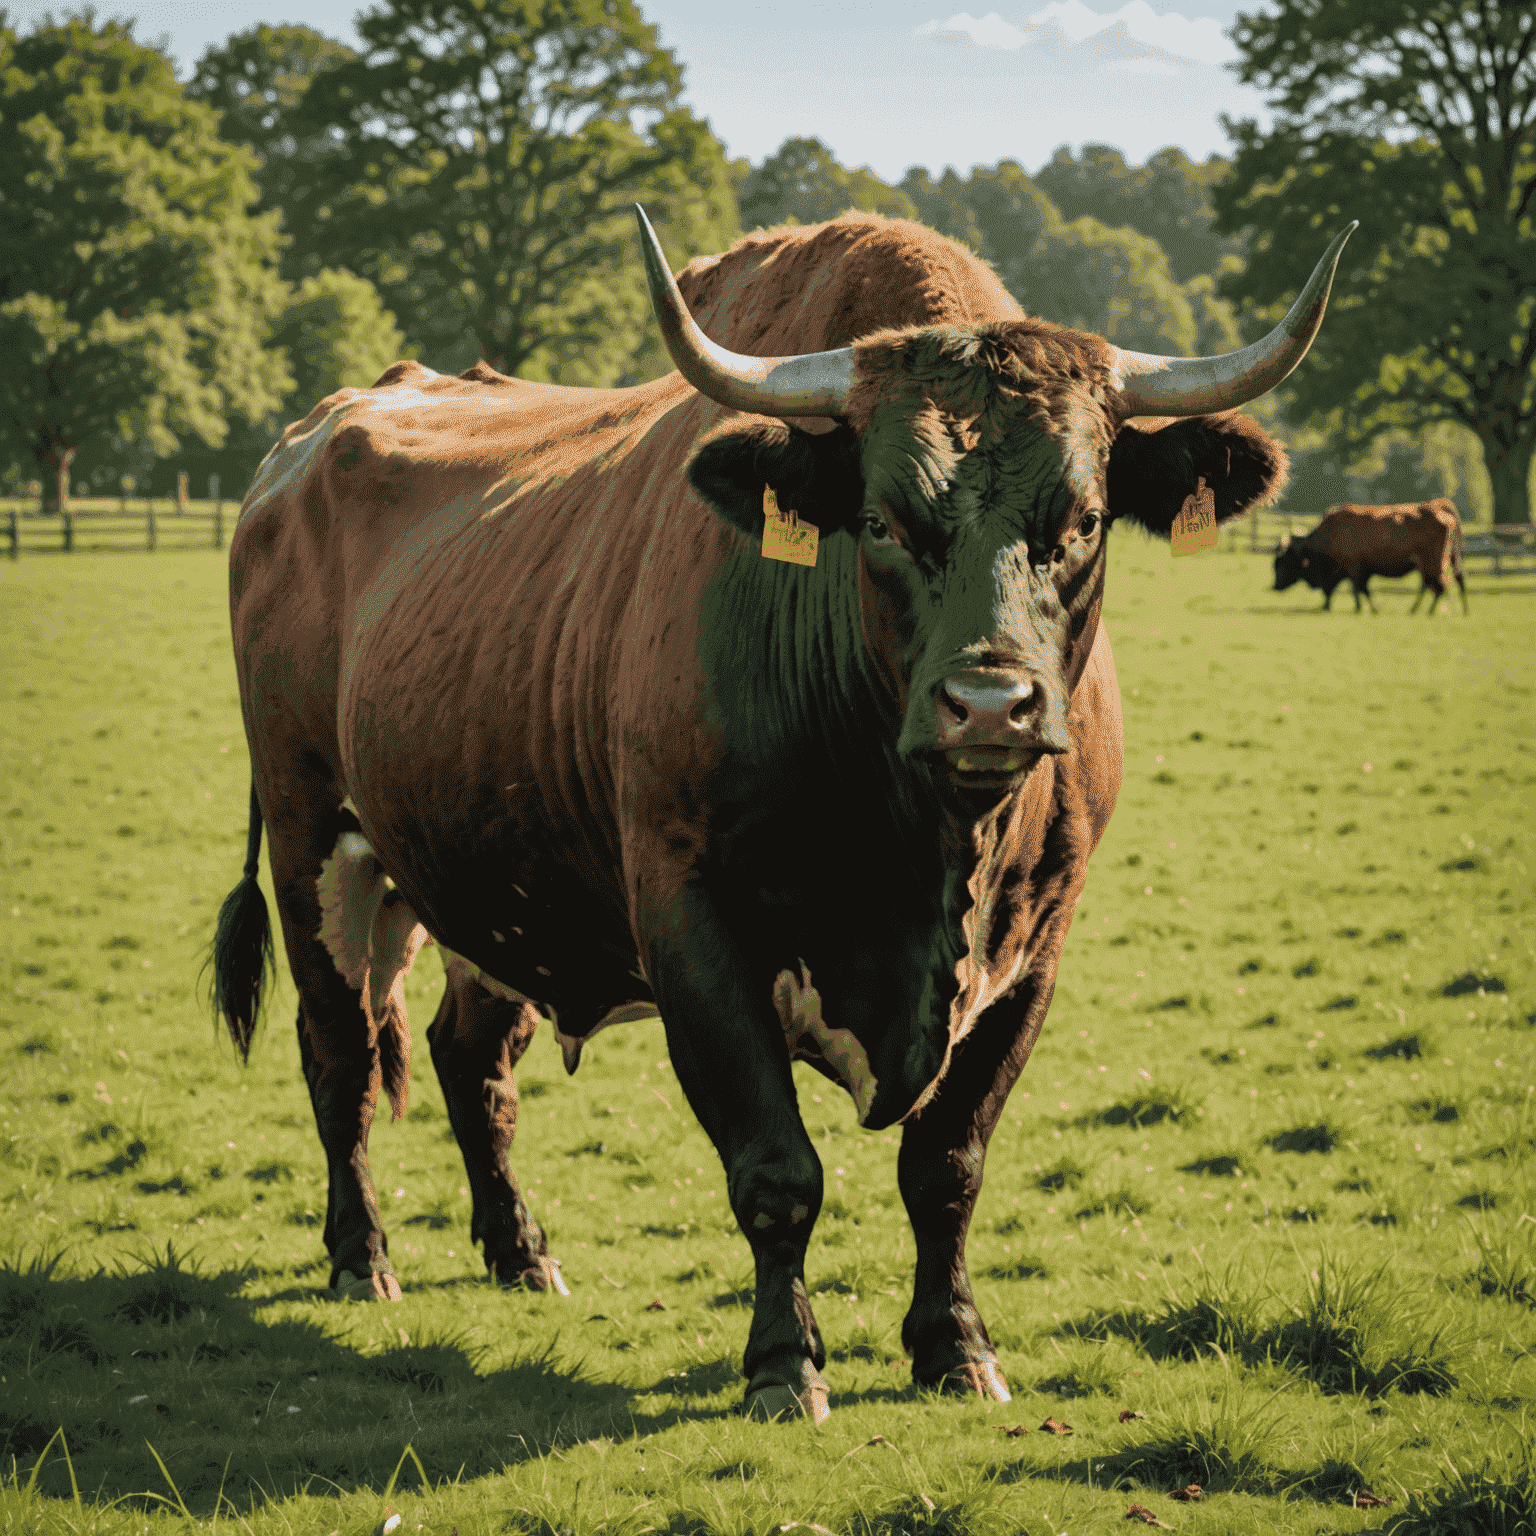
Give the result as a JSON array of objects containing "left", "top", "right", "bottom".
[{"left": 848, "top": 319, "right": 1115, "bottom": 498}]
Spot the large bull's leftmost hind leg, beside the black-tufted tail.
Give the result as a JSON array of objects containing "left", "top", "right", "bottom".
[{"left": 264, "top": 793, "right": 419, "bottom": 1301}]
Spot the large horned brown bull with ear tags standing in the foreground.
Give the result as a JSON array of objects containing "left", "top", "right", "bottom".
[{"left": 215, "top": 215, "right": 1344, "bottom": 1418}]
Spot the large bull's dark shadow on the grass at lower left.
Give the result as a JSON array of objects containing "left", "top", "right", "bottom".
[{"left": 0, "top": 1250, "right": 739, "bottom": 1516}]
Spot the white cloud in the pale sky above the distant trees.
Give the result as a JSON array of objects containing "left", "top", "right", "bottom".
[{"left": 915, "top": 0, "right": 1236, "bottom": 74}]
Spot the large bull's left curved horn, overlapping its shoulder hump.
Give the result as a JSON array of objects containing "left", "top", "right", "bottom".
[{"left": 634, "top": 203, "right": 854, "bottom": 416}]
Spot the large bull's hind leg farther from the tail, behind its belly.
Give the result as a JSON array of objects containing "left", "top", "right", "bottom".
[{"left": 427, "top": 957, "right": 570, "bottom": 1296}]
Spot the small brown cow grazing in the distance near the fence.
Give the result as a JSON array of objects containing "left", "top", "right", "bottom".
[{"left": 1275, "top": 496, "right": 1467, "bottom": 614}]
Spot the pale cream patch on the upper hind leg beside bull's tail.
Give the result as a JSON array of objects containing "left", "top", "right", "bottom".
[{"left": 315, "top": 833, "right": 430, "bottom": 1021}]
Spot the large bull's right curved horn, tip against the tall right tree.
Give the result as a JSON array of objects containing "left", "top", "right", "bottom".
[{"left": 1115, "top": 220, "right": 1359, "bottom": 416}]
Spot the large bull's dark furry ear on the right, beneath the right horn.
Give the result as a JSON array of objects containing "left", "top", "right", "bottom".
[{"left": 1107, "top": 412, "right": 1289, "bottom": 539}]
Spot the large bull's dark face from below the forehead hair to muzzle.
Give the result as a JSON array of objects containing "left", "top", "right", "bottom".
[{"left": 851, "top": 377, "right": 1107, "bottom": 791}]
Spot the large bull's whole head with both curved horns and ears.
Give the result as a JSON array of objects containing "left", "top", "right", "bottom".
[{"left": 636, "top": 209, "right": 1355, "bottom": 797}]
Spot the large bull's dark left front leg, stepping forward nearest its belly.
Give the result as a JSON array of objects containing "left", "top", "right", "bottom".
[{"left": 647, "top": 883, "right": 828, "bottom": 1421}]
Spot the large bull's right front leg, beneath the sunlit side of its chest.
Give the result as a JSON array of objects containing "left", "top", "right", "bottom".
[{"left": 897, "top": 980, "right": 1052, "bottom": 1402}]
